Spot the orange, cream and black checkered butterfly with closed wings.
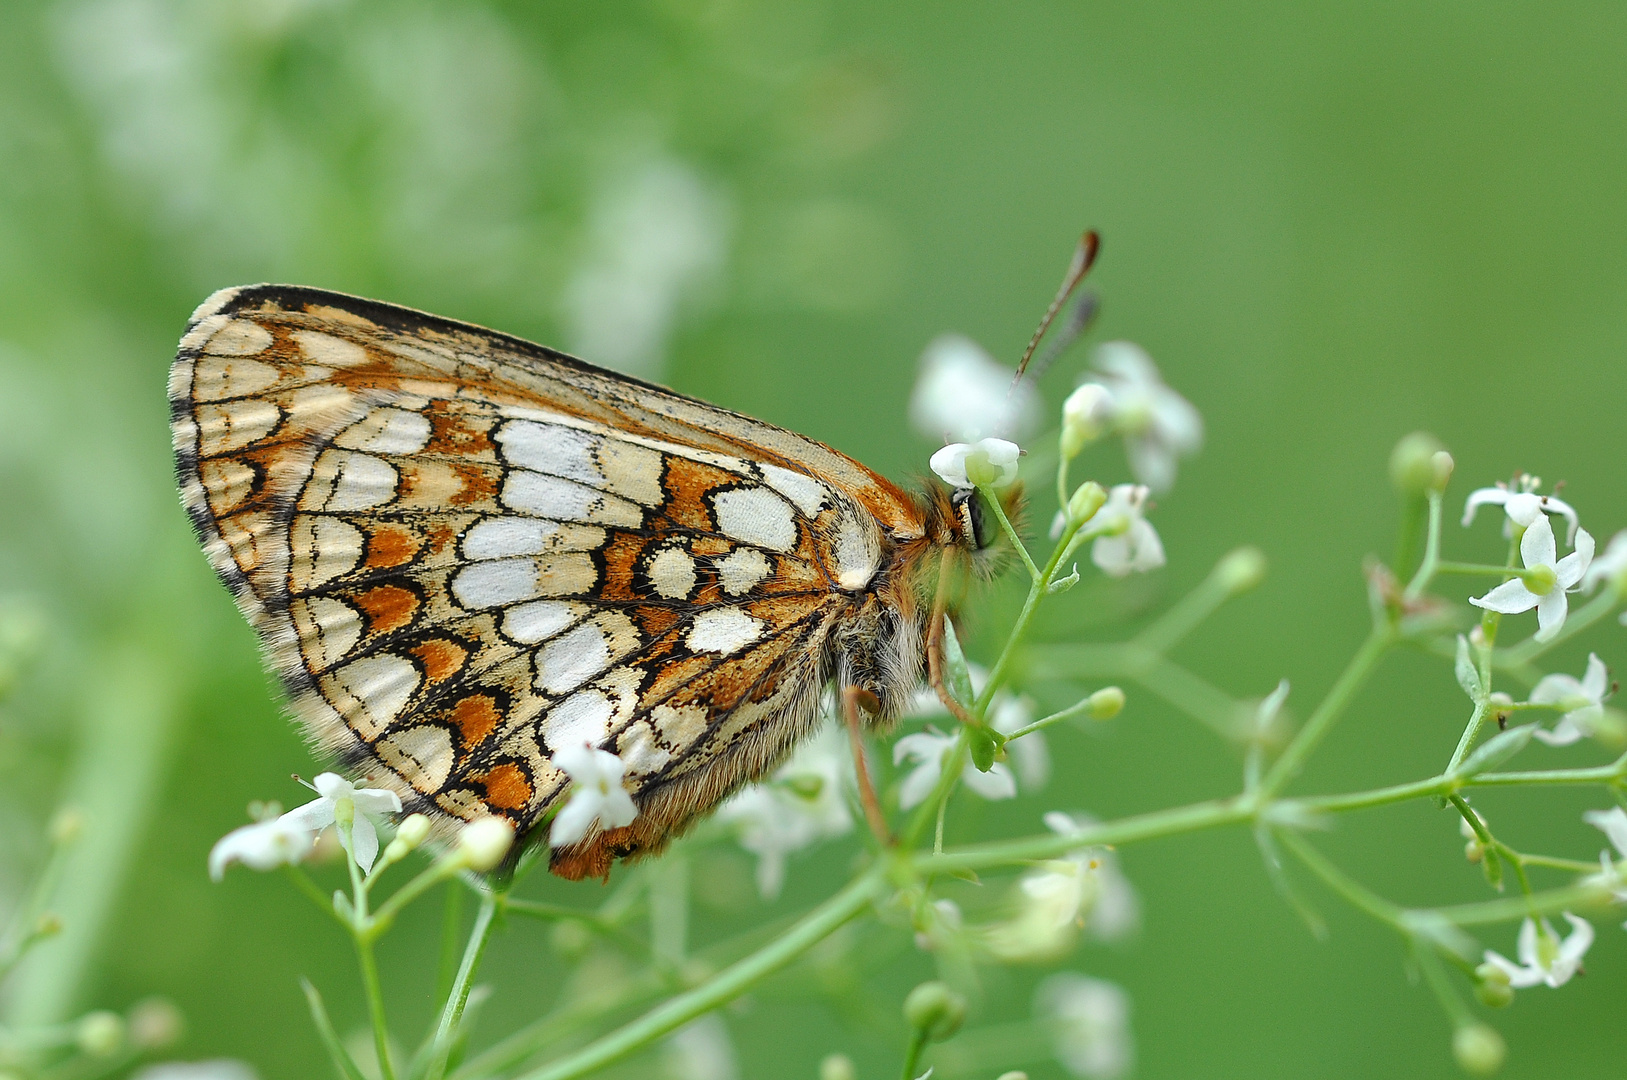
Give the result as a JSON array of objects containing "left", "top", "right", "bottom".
[{"left": 169, "top": 285, "right": 1021, "bottom": 878}]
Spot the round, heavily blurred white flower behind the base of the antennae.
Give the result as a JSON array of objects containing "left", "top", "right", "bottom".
[{"left": 909, "top": 333, "right": 1038, "bottom": 442}]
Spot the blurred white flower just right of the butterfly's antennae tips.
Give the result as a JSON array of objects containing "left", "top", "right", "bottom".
[{"left": 1097, "top": 342, "right": 1204, "bottom": 491}]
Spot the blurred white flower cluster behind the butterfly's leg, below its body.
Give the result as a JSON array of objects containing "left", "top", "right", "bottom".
[{"left": 718, "top": 727, "right": 853, "bottom": 899}]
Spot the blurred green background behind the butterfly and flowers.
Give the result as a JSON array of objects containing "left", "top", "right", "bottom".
[{"left": 0, "top": 0, "right": 1627, "bottom": 1080}]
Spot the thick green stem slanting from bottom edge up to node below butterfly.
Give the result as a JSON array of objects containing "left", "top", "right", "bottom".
[{"left": 521, "top": 864, "right": 887, "bottom": 1080}]
